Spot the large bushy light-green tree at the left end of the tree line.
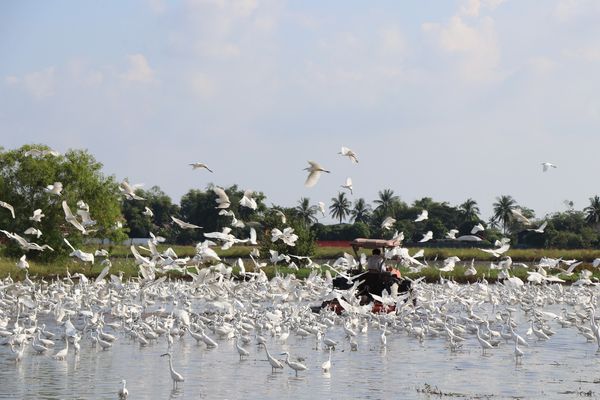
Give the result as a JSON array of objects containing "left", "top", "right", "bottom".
[{"left": 0, "top": 145, "right": 126, "bottom": 259}]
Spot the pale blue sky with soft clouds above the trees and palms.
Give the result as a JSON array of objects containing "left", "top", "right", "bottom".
[{"left": 0, "top": 0, "right": 600, "bottom": 220}]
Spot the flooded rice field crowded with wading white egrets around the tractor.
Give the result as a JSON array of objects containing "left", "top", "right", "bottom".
[{"left": 0, "top": 276, "right": 600, "bottom": 399}]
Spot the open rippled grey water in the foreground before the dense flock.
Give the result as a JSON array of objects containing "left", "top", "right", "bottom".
[{"left": 0, "top": 290, "right": 600, "bottom": 399}]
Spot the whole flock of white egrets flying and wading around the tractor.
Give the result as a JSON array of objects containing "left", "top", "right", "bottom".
[{"left": 0, "top": 148, "right": 600, "bottom": 398}]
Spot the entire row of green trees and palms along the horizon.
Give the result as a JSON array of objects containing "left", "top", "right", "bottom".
[{"left": 0, "top": 145, "right": 600, "bottom": 257}]
